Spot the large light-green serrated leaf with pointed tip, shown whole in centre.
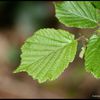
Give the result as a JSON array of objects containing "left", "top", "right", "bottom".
[{"left": 15, "top": 28, "right": 77, "bottom": 83}]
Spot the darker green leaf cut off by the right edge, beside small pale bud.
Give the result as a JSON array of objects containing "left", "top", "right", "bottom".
[{"left": 85, "top": 35, "right": 100, "bottom": 78}]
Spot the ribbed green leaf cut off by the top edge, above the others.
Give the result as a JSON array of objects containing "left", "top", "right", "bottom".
[{"left": 55, "top": 1, "right": 98, "bottom": 28}]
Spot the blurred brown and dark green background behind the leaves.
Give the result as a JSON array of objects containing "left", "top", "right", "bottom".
[{"left": 0, "top": 1, "right": 100, "bottom": 98}]
